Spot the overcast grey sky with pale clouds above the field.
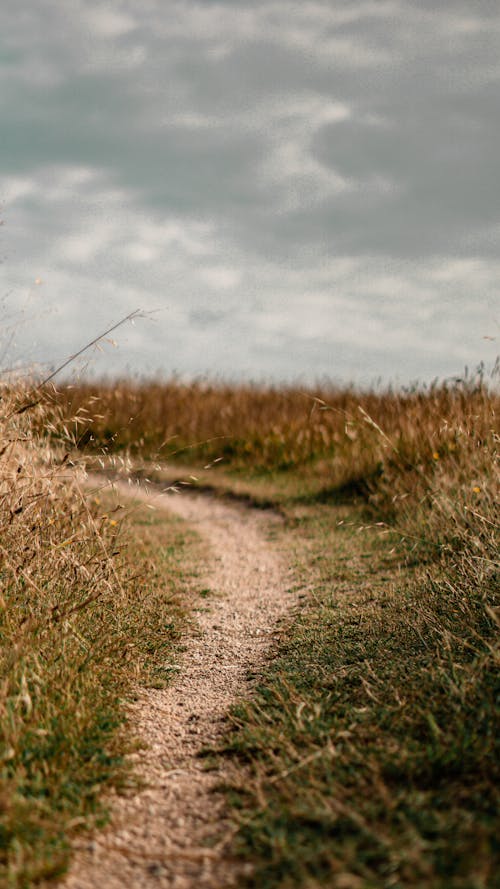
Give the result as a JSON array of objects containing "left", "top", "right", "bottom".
[{"left": 0, "top": 0, "right": 500, "bottom": 384}]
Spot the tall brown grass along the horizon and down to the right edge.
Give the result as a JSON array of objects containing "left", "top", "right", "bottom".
[{"left": 55, "top": 372, "right": 500, "bottom": 573}]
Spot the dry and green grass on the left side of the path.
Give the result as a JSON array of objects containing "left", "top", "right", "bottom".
[{"left": 0, "top": 386, "right": 205, "bottom": 889}]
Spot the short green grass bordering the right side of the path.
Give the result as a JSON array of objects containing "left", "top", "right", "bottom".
[{"left": 225, "top": 507, "right": 500, "bottom": 889}]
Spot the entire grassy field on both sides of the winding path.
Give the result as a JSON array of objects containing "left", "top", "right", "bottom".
[{"left": 0, "top": 373, "right": 500, "bottom": 889}]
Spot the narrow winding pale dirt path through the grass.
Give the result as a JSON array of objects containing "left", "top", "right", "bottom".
[{"left": 62, "top": 478, "right": 296, "bottom": 889}]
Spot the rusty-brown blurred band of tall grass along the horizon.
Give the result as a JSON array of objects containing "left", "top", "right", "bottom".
[{"left": 52, "top": 376, "right": 500, "bottom": 490}]
